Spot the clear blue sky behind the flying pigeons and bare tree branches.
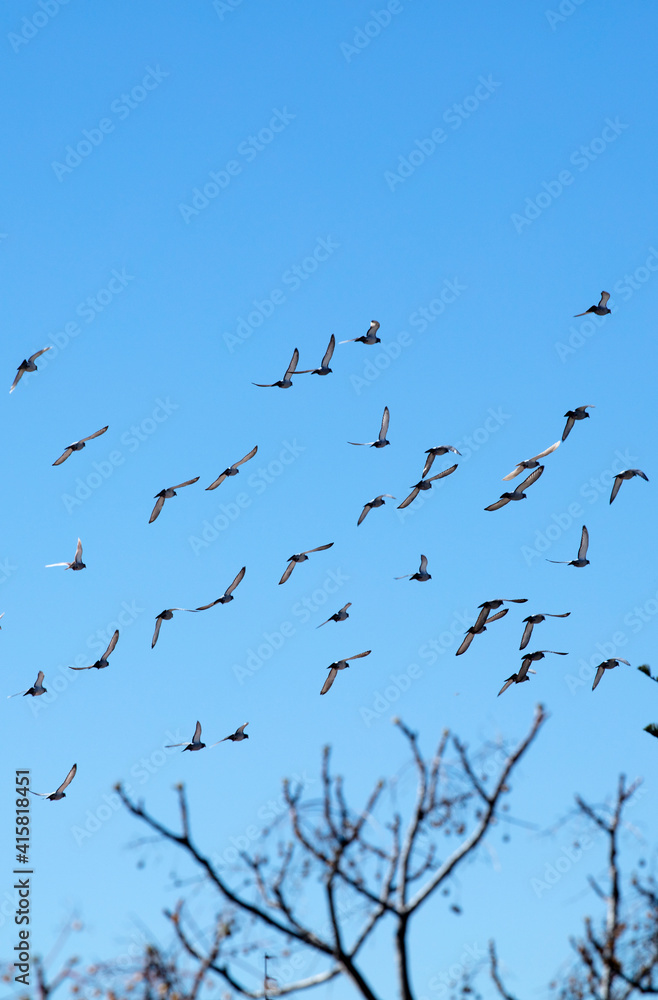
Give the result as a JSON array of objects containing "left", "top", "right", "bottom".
[{"left": 0, "top": 0, "right": 658, "bottom": 1000}]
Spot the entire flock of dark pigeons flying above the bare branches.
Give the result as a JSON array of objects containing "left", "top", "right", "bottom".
[{"left": 6, "top": 292, "right": 648, "bottom": 801}]
